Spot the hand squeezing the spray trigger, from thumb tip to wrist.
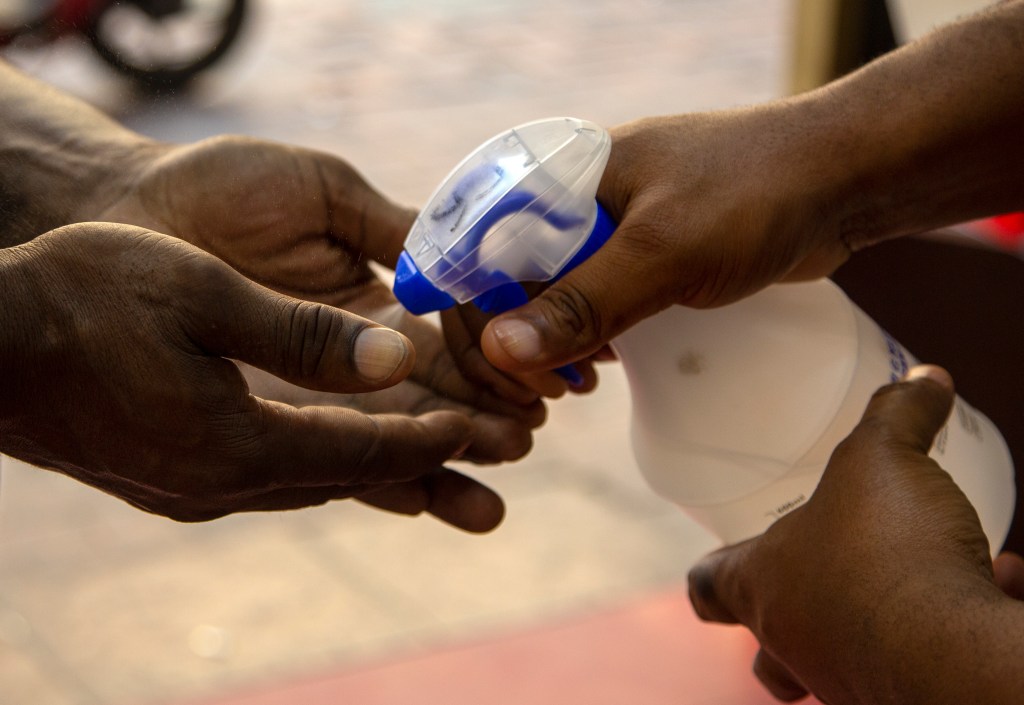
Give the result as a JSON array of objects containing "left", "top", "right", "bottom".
[{"left": 482, "top": 108, "right": 849, "bottom": 372}]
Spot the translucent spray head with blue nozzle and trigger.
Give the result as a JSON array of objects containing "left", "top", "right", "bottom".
[{"left": 394, "top": 118, "right": 615, "bottom": 381}]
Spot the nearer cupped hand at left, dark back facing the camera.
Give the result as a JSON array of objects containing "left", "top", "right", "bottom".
[{"left": 0, "top": 223, "right": 502, "bottom": 531}]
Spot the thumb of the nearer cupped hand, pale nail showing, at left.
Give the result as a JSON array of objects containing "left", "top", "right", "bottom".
[{"left": 187, "top": 259, "right": 416, "bottom": 393}]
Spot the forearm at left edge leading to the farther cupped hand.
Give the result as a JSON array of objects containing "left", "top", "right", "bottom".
[{"left": 0, "top": 61, "right": 150, "bottom": 247}]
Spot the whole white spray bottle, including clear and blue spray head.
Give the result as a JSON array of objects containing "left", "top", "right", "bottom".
[{"left": 394, "top": 118, "right": 1016, "bottom": 552}]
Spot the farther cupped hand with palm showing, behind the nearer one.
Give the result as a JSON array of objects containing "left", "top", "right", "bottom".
[{"left": 97, "top": 136, "right": 545, "bottom": 462}]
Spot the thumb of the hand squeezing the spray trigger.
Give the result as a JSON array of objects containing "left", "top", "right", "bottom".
[{"left": 480, "top": 222, "right": 672, "bottom": 372}]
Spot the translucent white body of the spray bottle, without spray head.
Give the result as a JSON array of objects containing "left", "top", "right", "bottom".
[{"left": 612, "top": 280, "right": 1016, "bottom": 551}]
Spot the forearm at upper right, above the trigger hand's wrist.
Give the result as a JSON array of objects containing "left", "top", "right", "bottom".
[{"left": 788, "top": 0, "right": 1024, "bottom": 249}]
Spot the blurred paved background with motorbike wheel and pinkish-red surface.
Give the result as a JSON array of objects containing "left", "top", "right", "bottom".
[{"left": 0, "top": 0, "right": 1003, "bottom": 705}]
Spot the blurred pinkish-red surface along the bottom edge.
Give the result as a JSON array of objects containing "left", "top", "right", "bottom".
[{"left": 186, "top": 590, "right": 790, "bottom": 705}]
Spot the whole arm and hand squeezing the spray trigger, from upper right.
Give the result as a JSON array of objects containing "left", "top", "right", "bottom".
[{"left": 481, "top": 0, "right": 1024, "bottom": 372}]
